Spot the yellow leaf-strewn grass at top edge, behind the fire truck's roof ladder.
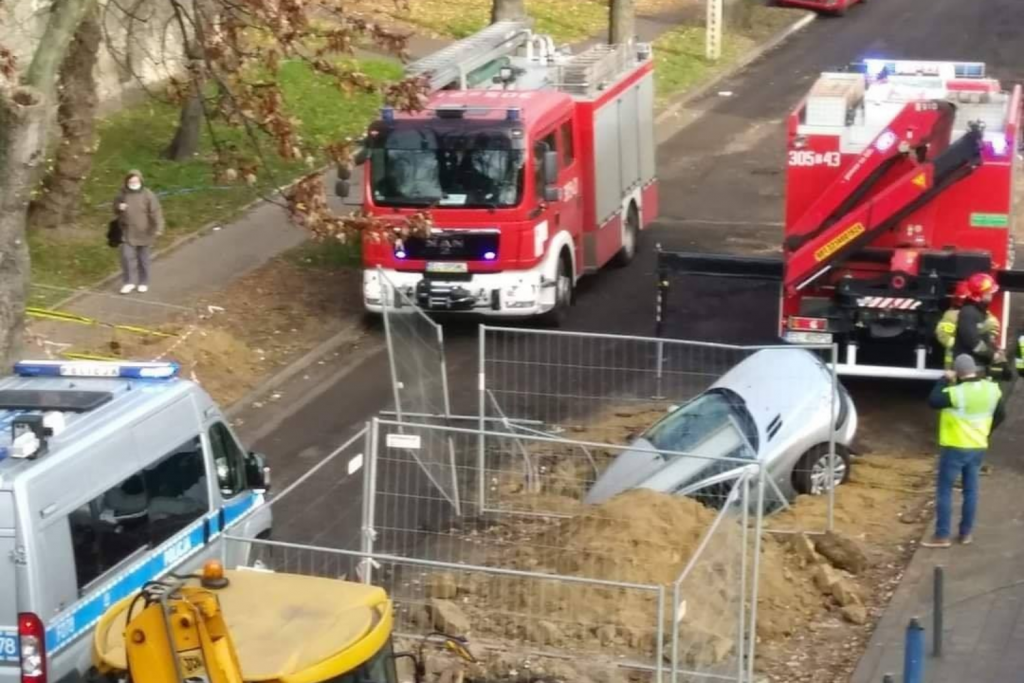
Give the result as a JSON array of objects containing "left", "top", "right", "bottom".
[{"left": 396, "top": 0, "right": 608, "bottom": 43}]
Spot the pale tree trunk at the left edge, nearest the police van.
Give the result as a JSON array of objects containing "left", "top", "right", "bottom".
[{"left": 0, "top": 0, "right": 93, "bottom": 368}]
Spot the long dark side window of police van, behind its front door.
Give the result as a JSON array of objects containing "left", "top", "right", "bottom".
[{"left": 69, "top": 436, "right": 210, "bottom": 591}]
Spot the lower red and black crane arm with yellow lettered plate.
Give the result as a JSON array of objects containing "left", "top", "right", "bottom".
[{"left": 782, "top": 120, "right": 982, "bottom": 294}]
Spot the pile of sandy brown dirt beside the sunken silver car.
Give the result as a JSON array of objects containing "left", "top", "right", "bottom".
[{"left": 432, "top": 444, "right": 933, "bottom": 667}]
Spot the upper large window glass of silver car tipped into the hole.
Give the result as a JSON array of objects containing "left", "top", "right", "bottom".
[{"left": 643, "top": 388, "right": 758, "bottom": 458}]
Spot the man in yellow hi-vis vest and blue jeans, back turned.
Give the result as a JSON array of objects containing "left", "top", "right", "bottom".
[{"left": 922, "top": 353, "right": 1006, "bottom": 548}]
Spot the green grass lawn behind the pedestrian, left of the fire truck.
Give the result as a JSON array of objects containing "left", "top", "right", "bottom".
[{"left": 30, "top": 59, "right": 401, "bottom": 304}]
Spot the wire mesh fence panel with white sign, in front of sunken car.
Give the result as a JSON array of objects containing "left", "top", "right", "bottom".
[{"left": 369, "top": 421, "right": 751, "bottom": 660}]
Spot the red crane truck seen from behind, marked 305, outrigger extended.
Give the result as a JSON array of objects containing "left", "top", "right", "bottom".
[{"left": 659, "top": 60, "right": 1024, "bottom": 379}]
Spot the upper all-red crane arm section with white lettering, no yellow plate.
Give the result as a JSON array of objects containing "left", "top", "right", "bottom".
[{"left": 785, "top": 100, "right": 956, "bottom": 250}]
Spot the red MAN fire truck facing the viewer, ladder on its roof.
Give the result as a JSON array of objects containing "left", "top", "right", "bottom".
[{"left": 338, "top": 22, "right": 657, "bottom": 323}]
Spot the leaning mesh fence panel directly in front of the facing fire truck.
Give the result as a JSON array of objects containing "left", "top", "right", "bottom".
[{"left": 378, "top": 270, "right": 461, "bottom": 514}]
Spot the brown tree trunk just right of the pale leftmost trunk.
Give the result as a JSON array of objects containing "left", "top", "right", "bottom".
[{"left": 29, "top": 9, "right": 103, "bottom": 228}]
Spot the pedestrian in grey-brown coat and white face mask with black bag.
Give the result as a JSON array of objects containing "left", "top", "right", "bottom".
[{"left": 114, "top": 169, "right": 164, "bottom": 294}]
